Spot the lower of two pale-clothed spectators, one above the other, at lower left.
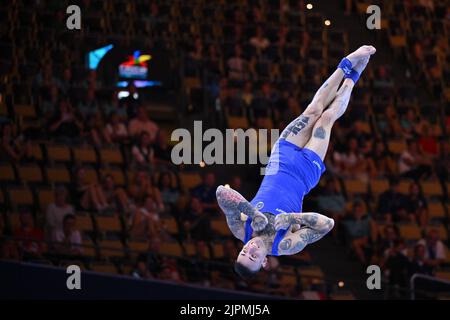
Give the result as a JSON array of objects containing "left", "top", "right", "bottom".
[{"left": 52, "top": 214, "right": 83, "bottom": 255}]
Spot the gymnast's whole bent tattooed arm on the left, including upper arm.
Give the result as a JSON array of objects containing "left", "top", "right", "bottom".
[{"left": 216, "top": 186, "right": 267, "bottom": 240}]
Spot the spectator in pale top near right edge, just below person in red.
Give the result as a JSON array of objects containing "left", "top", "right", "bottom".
[{"left": 398, "top": 140, "right": 431, "bottom": 180}]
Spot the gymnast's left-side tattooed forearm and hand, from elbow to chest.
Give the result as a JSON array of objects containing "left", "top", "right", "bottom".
[{"left": 216, "top": 186, "right": 268, "bottom": 231}]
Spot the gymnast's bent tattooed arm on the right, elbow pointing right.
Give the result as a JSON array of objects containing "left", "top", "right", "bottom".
[{"left": 275, "top": 212, "right": 334, "bottom": 255}]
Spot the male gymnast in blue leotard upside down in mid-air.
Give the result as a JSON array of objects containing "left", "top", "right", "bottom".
[{"left": 216, "top": 46, "right": 376, "bottom": 278}]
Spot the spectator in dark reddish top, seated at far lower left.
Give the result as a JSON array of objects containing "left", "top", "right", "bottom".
[{"left": 14, "top": 209, "right": 46, "bottom": 260}]
